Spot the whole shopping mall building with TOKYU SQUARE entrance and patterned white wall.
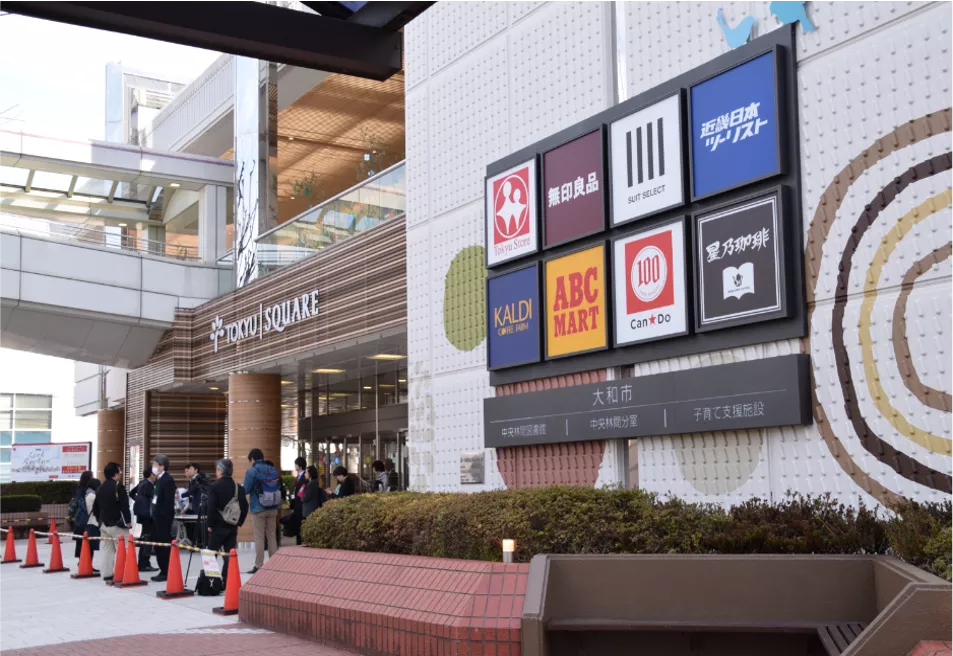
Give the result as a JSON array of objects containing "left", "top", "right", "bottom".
[{"left": 0, "top": 2, "right": 953, "bottom": 504}]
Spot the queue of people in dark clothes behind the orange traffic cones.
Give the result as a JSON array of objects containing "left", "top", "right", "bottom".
[{"left": 63, "top": 449, "right": 399, "bottom": 588}]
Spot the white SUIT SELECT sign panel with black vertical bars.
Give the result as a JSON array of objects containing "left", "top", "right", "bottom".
[{"left": 609, "top": 94, "right": 685, "bottom": 225}]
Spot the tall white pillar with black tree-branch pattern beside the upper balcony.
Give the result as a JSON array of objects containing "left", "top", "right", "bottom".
[{"left": 234, "top": 57, "right": 278, "bottom": 288}]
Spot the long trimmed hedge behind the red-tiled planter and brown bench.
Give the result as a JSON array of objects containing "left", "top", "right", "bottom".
[{"left": 302, "top": 487, "right": 953, "bottom": 580}]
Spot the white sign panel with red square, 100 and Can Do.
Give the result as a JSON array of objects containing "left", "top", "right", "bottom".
[{"left": 612, "top": 219, "right": 688, "bottom": 345}]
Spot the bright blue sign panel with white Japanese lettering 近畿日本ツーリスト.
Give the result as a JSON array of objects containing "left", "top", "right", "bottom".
[{"left": 691, "top": 51, "right": 781, "bottom": 198}]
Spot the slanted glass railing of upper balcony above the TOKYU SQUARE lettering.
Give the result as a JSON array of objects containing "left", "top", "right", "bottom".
[{"left": 258, "top": 162, "right": 407, "bottom": 277}]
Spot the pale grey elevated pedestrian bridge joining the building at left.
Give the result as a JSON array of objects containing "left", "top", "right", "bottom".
[{"left": 0, "top": 131, "right": 233, "bottom": 368}]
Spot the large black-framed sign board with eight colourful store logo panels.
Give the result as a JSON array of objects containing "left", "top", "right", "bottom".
[{"left": 485, "top": 26, "right": 807, "bottom": 385}]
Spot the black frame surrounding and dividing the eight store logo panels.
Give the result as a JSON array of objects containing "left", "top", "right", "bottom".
[{"left": 484, "top": 25, "right": 807, "bottom": 386}]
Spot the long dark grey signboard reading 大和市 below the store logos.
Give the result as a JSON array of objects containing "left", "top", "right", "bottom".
[{"left": 483, "top": 355, "right": 811, "bottom": 447}]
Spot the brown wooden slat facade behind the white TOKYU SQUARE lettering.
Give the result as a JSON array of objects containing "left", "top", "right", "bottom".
[{"left": 126, "top": 217, "right": 407, "bottom": 479}]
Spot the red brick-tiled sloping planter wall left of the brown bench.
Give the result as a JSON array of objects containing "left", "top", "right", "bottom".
[{"left": 239, "top": 547, "right": 529, "bottom": 656}]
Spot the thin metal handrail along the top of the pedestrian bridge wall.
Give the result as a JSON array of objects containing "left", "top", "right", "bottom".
[{"left": 0, "top": 214, "right": 201, "bottom": 261}]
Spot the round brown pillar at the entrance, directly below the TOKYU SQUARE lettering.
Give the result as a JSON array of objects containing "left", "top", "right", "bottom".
[{"left": 228, "top": 374, "right": 281, "bottom": 542}]
